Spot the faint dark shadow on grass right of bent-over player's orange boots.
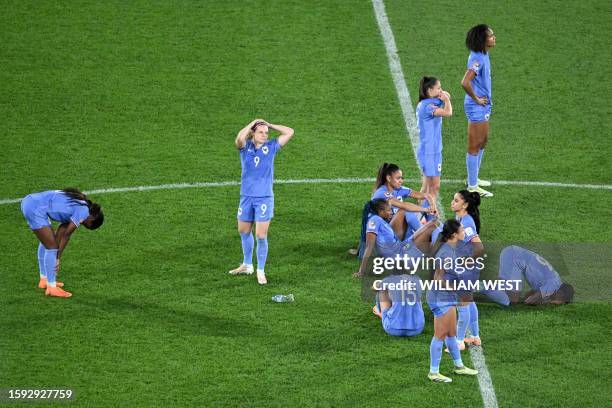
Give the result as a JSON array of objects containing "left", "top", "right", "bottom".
[{"left": 73, "top": 296, "right": 265, "bottom": 338}]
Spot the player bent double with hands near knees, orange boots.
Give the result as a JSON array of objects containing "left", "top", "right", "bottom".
[{"left": 21, "top": 188, "right": 104, "bottom": 297}]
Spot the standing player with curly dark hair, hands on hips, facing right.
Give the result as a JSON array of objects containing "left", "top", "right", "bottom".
[{"left": 461, "top": 24, "right": 495, "bottom": 197}]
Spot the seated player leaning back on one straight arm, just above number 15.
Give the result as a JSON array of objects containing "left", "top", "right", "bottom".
[{"left": 353, "top": 200, "right": 437, "bottom": 278}]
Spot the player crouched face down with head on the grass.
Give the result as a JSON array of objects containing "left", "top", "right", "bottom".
[{"left": 483, "top": 245, "right": 574, "bottom": 306}]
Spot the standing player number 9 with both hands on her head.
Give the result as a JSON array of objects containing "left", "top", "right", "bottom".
[{"left": 229, "top": 119, "right": 293, "bottom": 285}]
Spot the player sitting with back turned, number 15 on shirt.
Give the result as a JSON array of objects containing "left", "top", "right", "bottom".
[{"left": 372, "top": 274, "right": 425, "bottom": 336}]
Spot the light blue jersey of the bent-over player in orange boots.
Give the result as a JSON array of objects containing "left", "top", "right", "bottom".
[{"left": 21, "top": 190, "right": 89, "bottom": 230}]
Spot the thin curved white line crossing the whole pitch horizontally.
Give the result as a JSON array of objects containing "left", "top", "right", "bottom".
[{"left": 0, "top": 177, "right": 612, "bottom": 205}]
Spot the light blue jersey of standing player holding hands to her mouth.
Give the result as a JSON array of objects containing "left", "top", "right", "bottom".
[{"left": 416, "top": 98, "right": 444, "bottom": 157}]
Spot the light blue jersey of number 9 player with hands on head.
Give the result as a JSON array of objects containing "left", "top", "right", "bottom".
[{"left": 240, "top": 139, "right": 281, "bottom": 197}]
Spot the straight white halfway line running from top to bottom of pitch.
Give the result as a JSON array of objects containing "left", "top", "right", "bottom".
[{"left": 372, "top": 0, "right": 497, "bottom": 408}]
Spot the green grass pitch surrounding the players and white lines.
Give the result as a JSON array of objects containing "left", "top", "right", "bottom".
[{"left": 0, "top": 0, "right": 612, "bottom": 407}]
